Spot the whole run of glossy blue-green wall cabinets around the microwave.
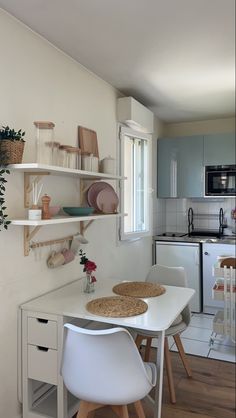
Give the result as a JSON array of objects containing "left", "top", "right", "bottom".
[{"left": 157, "top": 133, "right": 236, "bottom": 198}]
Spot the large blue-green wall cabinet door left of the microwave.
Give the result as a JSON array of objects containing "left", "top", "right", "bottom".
[{"left": 157, "top": 136, "right": 204, "bottom": 198}]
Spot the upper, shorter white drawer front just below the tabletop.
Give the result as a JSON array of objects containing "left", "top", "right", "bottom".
[{"left": 28, "top": 317, "right": 57, "bottom": 349}]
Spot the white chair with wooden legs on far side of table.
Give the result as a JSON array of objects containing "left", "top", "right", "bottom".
[{"left": 135, "top": 264, "right": 192, "bottom": 403}]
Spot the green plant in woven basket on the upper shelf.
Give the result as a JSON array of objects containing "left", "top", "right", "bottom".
[{"left": 0, "top": 126, "right": 25, "bottom": 165}]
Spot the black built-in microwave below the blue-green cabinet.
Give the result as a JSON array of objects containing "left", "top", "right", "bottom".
[{"left": 205, "top": 164, "right": 236, "bottom": 196}]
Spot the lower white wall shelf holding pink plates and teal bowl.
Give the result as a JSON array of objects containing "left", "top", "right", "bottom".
[{"left": 11, "top": 213, "right": 123, "bottom": 226}]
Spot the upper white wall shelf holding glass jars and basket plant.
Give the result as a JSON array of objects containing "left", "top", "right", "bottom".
[{"left": 8, "top": 163, "right": 125, "bottom": 180}]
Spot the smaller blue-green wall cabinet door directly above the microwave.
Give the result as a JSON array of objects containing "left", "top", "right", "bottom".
[{"left": 204, "top": 133, "right": 236, "bottom": 165}]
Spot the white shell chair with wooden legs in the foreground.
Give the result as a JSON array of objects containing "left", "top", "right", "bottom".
[{"left": 61, "top": 324, "right": 156, "bottom": 418}]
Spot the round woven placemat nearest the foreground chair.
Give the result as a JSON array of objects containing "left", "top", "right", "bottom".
[{"left": 86, "top": 296, "right": 148, "bottom": 318}]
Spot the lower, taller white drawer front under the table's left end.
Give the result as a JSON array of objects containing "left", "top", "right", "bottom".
[{"left": 28, "top": 345, "right": 58, "bottom": 385}]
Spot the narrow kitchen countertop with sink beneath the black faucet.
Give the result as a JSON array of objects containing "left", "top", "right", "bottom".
[{"left": 153, "top": 235, "right": 236, "bottom": 244}]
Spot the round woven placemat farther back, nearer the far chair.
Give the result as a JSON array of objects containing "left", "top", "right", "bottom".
[{"left": 112, "top": 282, "right": 166, "bottom": 298}]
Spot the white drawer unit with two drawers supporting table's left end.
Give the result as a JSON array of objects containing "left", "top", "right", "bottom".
[{"left": 18, "top": 309, "right": 80, "bottom": 418}]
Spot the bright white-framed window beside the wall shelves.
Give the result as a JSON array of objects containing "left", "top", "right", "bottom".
[{"left": 120, "top": 128, "right": 151, "bottom": 240}]
